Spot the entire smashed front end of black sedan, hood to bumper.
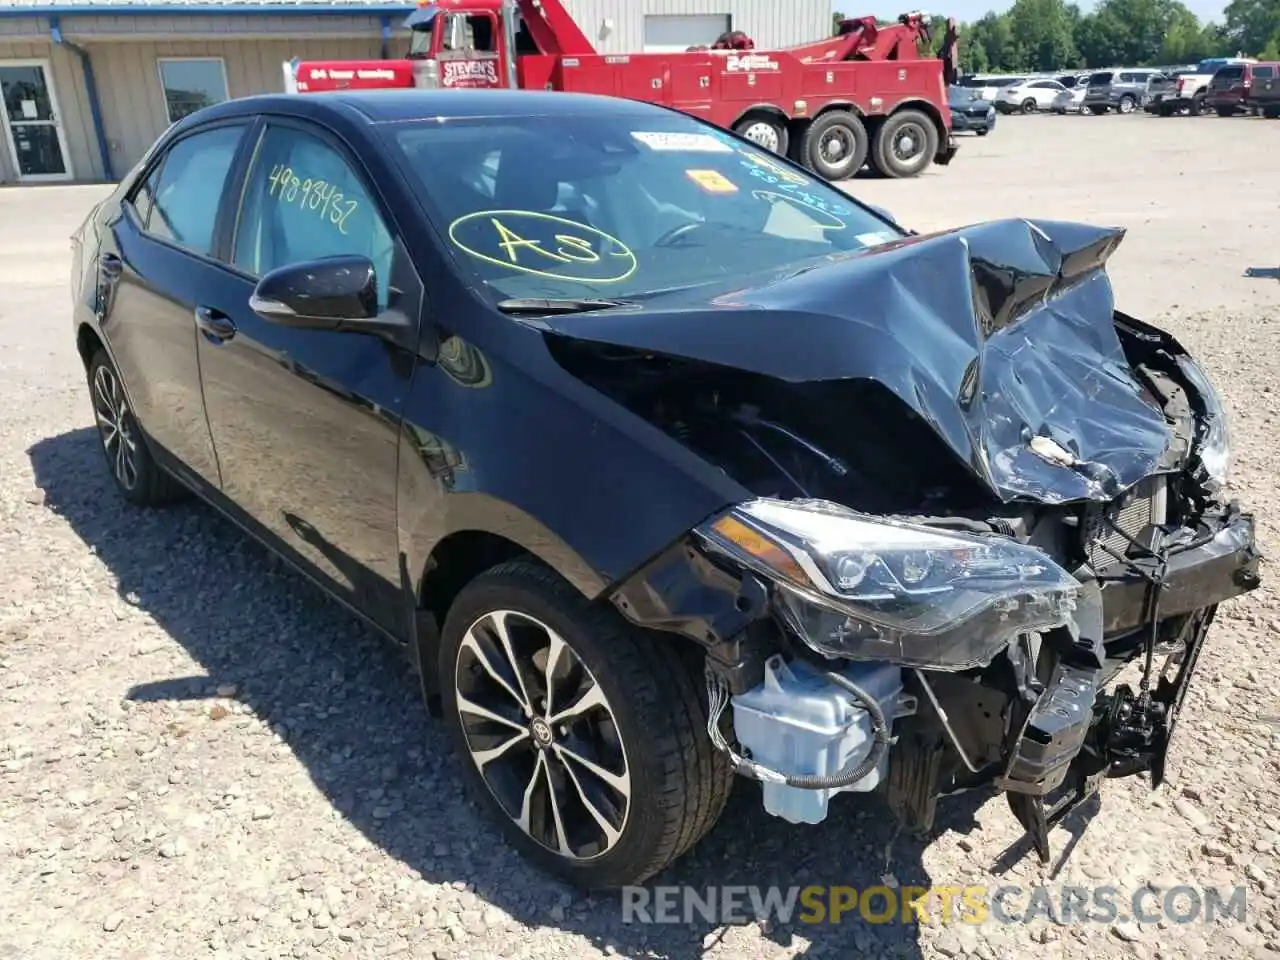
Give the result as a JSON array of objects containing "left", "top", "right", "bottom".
[{"left": 570, "top": 220, "right": 1258, "bottom": 861}]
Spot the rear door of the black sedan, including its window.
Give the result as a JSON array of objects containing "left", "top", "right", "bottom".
[{"left": 100, "top": 120, "right": 250, "bottom": 488}]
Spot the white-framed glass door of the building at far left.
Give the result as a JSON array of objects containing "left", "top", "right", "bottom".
[{"left": 0, "top": 60, "right": 72, "bottom": 183}]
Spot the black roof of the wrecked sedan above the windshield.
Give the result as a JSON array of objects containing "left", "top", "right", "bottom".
[{"left": 200, "top": 90, "right": 672, "bottom": 123}]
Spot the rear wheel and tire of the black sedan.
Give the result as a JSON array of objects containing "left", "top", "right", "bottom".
[{"left": 87, "top": 349, "right": 187, "bottom": 507}]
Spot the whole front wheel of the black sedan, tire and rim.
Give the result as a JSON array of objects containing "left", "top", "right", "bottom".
[{"left": 439, "top": 559, "right": 733, "bottom": 890}]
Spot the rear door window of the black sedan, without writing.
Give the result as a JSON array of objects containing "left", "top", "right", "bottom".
[{"left": 144, "top": 124, "right": 244, "bottom": 256}]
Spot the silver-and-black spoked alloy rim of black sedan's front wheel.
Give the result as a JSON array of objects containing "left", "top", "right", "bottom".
[{"left": 454, "top": 611, "right": 631, "bottom": 861}]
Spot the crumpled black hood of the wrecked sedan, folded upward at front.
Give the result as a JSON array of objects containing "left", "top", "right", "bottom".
[{"left": 540, "top": 219, "right": 1171, "bottom": 503}]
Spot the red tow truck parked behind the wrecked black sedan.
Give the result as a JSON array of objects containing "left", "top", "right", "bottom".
[{"left": 284, "top": 0, "right": 956, "bottom": 180}]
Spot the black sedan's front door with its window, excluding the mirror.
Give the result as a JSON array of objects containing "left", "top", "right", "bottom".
[{"left": 198, "top": 118, "right": 422, "bottom": 634}]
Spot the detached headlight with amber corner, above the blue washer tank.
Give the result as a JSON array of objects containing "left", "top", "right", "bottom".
[{"left": 695, "top": 499, "right": 1079, "bottom": 669}]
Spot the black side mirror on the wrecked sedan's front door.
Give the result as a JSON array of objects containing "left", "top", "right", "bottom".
[{"left": 248, "top": 255, "right": 378, "bottom": 330}]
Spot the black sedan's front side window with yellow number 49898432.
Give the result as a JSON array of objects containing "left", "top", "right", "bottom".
[{"left": 234, "top": 127, "right": 394, "bottom": 308}]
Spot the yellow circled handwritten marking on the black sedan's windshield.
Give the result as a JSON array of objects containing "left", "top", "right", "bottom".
[{"left": 449, "top": 210, "right": 636, "bottom": 283}]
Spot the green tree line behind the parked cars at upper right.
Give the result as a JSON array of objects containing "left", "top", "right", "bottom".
[{"left": 835, "top": 0, "right": 1280, "bottom": 73}]
